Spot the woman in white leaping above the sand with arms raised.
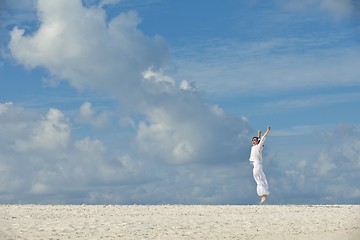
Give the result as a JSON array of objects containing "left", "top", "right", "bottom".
[{"left": 249, "top": 126, "right": 270, "bottom": 203}]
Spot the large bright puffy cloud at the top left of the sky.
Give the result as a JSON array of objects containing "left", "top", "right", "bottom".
[{"left": 9, "top": 0, "right": 167, "bottom": 96}]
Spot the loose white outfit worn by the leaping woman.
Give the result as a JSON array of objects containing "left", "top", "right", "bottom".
[{"left": 249, "top": 137, "right": 270, "bottom": 196}]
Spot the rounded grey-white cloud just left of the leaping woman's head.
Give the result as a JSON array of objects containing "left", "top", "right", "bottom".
[{"left": 136, "top": 79, "right": 249, "bottom": 164}]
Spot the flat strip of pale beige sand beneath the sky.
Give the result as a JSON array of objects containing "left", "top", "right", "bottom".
[{"left": 0, "top": 205, "right": 360, "bottom": 240}]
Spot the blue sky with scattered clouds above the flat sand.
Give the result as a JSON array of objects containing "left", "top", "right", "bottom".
[{"left": 0, "top": 0, "right": 360, "bottom": 204}]
